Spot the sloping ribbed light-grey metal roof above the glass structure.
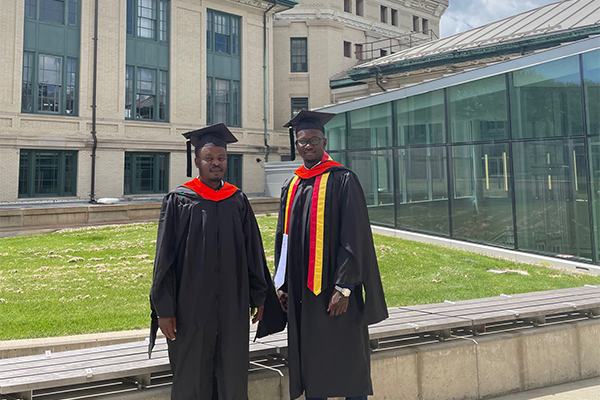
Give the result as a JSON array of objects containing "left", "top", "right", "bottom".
[{"left": 349, "top": 0, "right": 600, "bottom": 72}]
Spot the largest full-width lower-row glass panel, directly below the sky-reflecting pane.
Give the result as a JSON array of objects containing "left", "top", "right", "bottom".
[{"left": 513, "top": 139, "right": 592, "bottom": 260}]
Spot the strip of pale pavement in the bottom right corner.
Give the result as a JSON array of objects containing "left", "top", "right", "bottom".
[{"left": 489, "top": 377, "right": 600, "bottom": 400}]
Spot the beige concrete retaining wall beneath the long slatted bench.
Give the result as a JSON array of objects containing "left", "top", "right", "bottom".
[{"left": 56, "top": 318, "right": 600, "bottom": 400}]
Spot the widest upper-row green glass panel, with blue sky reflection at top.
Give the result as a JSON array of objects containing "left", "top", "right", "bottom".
[{"left": 510, "top": 56, "right": 583, "bottom": 138}]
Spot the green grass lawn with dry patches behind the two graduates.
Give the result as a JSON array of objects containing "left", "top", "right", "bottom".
[{"left": 0, "top": 217, "right": 600, "bottom": 340}]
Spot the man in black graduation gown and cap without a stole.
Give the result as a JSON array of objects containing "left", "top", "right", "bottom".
[{"left": 149, "top": 124, "right": 275, "bottom": 400}]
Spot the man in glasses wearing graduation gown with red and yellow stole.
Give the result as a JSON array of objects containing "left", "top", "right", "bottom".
[{"left": 275, "top": 111, "right": 388, "bottom": 400}]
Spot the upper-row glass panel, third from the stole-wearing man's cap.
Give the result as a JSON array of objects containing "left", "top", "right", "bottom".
[{"left": 395, "top": 90, "right": 446, "bottom": 146}]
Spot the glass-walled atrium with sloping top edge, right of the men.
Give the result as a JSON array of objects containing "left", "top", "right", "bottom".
[{"left": 322, "top": 39, "right": 600, "bottom": 263}]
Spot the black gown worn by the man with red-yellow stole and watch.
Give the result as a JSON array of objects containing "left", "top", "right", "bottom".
[{"left": 275, "top": 166, "right": 388, "bottom": 399}]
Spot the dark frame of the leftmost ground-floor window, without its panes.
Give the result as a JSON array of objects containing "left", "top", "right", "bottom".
[{"left": 18, "top": 149, "right": 78, "bottom": 198}]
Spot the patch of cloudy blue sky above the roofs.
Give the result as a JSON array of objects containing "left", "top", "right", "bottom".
[{"left": 440, "top": 0, "right": 558, "bottom": 37}]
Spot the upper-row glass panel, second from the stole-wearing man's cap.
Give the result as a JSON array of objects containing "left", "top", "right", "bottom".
[{"left": 348, "top": 103, "right": 392, "bottom": 149}]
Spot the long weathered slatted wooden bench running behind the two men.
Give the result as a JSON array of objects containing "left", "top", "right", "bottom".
[{"left": 0, "top": 285, "right": 600, "bottom": 400}]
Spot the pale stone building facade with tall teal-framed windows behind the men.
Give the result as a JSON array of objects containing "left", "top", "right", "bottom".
[{"left": 0, "top": 0, "right": 447, "bottom": 202}]
